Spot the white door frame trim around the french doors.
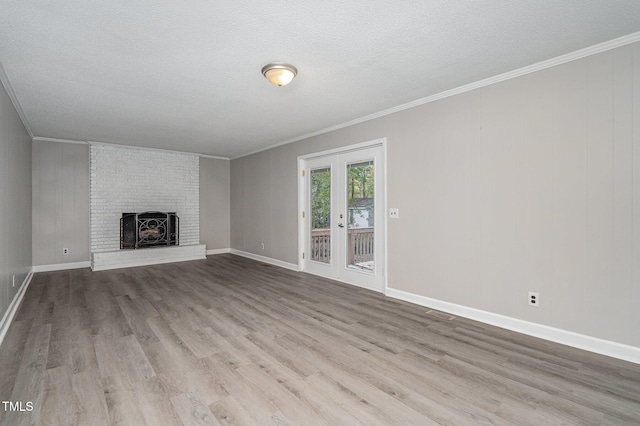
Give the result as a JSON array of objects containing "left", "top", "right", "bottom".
[{"left": 298, "top": 138, "right": 388, "bottom": 294}]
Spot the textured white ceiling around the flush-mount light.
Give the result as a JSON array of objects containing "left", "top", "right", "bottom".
[{"left": 0, "top": 0, "right": 640, "bottom": 157}]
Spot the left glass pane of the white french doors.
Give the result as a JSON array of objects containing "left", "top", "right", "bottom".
[{"left": 309, "top": 167, "right": 331, "bottom": 263}]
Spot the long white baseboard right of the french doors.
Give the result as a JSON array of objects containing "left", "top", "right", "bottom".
[{"left": 385, "top": 288, "right": 640, "bottom": 364}]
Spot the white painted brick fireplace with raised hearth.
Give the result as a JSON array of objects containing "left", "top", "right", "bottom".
[{"left": 91, "top": 144, "right": 206, "bottom": 271}]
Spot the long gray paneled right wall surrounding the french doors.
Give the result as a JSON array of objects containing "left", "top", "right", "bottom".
[{"left": 231, "top": 43, "right": 640, "bottom": 347}]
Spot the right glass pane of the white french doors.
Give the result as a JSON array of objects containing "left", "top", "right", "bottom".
[{"left": 347, "top": 161, "right": 375, "bottom": 272}]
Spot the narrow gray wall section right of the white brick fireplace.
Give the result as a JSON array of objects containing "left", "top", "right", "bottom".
[{"left": 200, "top": 157, "right": 231, "bottom": 250}]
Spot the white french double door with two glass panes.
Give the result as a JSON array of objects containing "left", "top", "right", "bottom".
[{"left": 300, "top": 145, "right": 385, "bottom": 292}]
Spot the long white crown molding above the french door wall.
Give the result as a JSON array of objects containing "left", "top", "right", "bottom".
[{"left": 231, "top": 31, "right": 640, "bottom": 160}]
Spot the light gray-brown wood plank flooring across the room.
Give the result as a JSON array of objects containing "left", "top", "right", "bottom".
[{"left": 0, "top": 254, "right": 640, "bottom": 426}]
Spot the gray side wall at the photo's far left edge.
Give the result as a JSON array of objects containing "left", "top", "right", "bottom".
[{"left": 0, "top": 80, "right": 31, "bottom": 319}]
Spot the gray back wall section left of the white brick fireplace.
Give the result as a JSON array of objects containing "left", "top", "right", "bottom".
[{"left": 33, "top": 140, "right": 90, "bottom": 266}]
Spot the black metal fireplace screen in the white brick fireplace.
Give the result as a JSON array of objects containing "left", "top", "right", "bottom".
[{"left": 120, "top": 212, "right": 180, "bottom": 249}]
